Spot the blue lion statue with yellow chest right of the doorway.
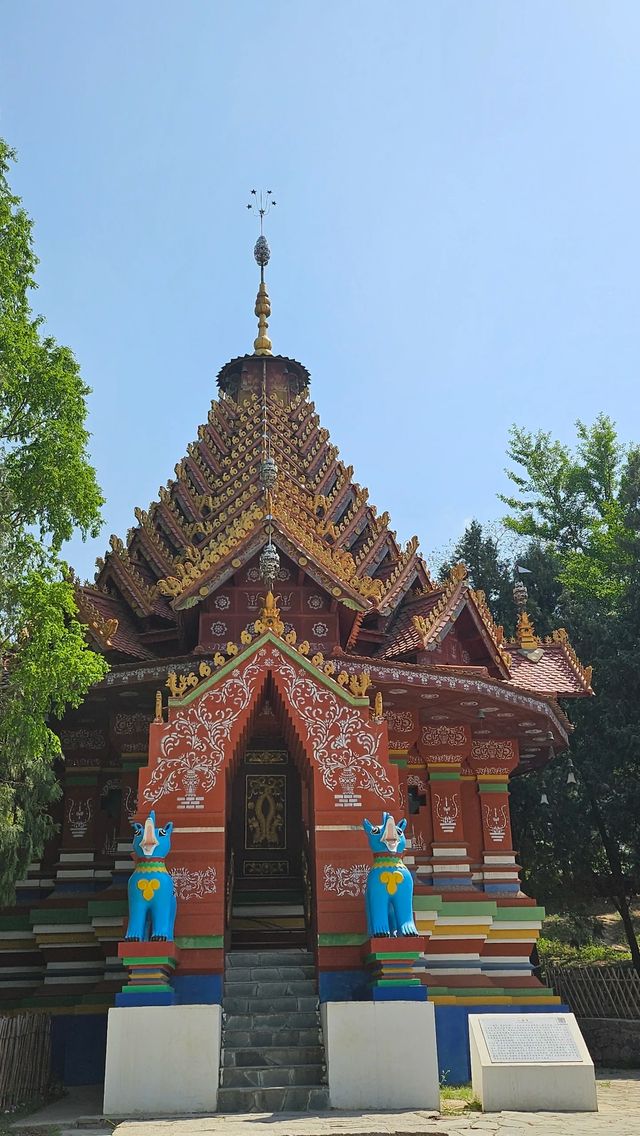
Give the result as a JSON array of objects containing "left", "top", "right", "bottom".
[{"left": 363, "top": 812, "right": 418, "bottom": 937}]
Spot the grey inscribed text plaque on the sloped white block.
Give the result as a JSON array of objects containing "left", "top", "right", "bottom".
[{"left": 479, "top": 1013, "right": 582, "bottom": 1064}]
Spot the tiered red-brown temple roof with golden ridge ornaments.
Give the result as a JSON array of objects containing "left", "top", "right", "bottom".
[{"left": 77, "top": 356, "right": 591, "bottom": 698}]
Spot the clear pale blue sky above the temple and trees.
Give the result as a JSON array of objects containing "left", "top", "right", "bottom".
[{"left": 0, "top": 0, "right": 640, "bottom": 576}]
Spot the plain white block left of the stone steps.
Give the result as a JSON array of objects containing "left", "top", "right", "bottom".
[{"left": 105, "top": 1005, "right": 222, "bottom": 1117}]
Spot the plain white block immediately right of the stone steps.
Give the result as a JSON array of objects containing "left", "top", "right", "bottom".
[{"left": 321, "top": 1002, "right": 440, "bottom": 1110}]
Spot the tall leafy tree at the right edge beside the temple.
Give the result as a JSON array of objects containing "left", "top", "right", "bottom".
[{"left": 502, "top": 415, "right": 640, "bottom": 969}]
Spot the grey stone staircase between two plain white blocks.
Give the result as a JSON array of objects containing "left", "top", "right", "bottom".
[{"left": 218, "top": 947, "right": 329, "bottom": 1112}]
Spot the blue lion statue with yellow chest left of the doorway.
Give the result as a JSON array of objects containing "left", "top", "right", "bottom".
[{"left": 125, "top": 812, "right": 177, "bottom": 943}]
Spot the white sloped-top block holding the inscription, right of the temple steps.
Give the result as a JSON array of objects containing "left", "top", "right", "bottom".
[{"left": 468, "top": 1013, "right": 598, "bottom": 1112}]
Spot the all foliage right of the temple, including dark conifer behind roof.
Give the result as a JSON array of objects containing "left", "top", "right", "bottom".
[{"left": 443, "top": 415, "right": 640, "bottom": 968}]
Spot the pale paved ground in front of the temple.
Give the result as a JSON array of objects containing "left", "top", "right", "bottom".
[{"left": 11, "top": 1072, "right": 640, "bottom": 1136}]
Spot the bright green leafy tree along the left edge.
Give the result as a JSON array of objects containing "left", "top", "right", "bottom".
[{"left": 0, "top": 140, "right": 106, "bottom": 902}]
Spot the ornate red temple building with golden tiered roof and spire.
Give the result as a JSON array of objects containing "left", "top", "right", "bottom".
[{"left": 0, "top": 214, "right": 592, "bottom": 1099}]
